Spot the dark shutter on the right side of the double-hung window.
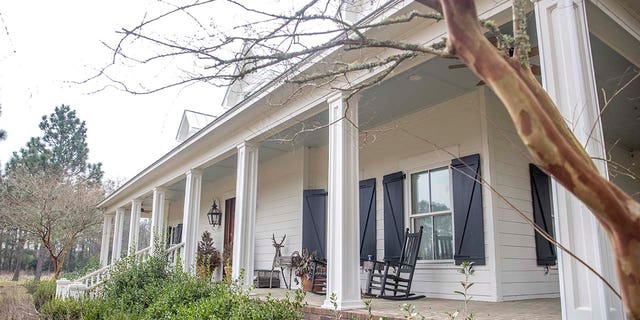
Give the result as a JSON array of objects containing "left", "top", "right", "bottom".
[{"left": 451, "top": 154, "right": 485, "bottom": 265}]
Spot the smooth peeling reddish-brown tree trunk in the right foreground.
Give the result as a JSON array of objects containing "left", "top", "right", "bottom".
[{"left": 419, "top": 0, "right": 640, "bottom": 319}]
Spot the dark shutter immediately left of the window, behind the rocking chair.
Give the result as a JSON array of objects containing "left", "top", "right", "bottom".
[{"left": 382, "top": 171, "right": 405, "bottom": 260}]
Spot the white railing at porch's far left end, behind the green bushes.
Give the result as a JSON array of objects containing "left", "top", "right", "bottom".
[{"left": 56, "top": 242, "right": 184, "bottom": 299}]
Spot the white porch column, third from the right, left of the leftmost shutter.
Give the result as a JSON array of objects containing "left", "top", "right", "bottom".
[{"left": 231, "top": 142, "right": 258, "bottom": 286}]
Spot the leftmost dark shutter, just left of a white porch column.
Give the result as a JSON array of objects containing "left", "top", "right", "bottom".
[{"left": 302, "top": 189, "right": 327, "bottom": 259}]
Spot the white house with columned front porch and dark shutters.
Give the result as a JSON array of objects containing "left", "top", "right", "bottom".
[{"left": 86, "top": 0, "right": 640, "bottom": 319}]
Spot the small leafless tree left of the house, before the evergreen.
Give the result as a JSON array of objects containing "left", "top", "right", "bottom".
[{"left": 0, "top": 168, "right": 104, "bottom": 278}]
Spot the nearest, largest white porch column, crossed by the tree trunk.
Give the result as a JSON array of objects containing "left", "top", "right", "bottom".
[{"left": 535, "top": 0, "right": 622, "bottom": 319}]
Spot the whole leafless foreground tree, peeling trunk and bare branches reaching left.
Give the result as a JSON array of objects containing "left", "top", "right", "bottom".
[{"left": 84, "top": 0, "right": 640, "bottom": 319}]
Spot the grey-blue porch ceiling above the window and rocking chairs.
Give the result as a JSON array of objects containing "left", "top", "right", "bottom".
[{"left": 260, "top": 58, "right": 488, "bottom": 155}]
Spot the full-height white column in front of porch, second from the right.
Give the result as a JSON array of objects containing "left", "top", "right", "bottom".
[{"left": 322, "top": 94, "right": 364, "bottom": 310}]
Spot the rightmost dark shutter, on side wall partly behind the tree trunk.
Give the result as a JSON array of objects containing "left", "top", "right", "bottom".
[{"left": 529, "top": 163, "right": 556, "bottom": 266}]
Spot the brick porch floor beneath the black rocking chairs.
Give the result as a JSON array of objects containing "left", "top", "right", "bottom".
[{"left": 254, "top": 289, "right": 562, "bottom": 320}]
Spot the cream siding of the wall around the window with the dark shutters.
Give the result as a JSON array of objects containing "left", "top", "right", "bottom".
[{"left": 360, "top": 92, "right": 496, "bottom": 301}]
